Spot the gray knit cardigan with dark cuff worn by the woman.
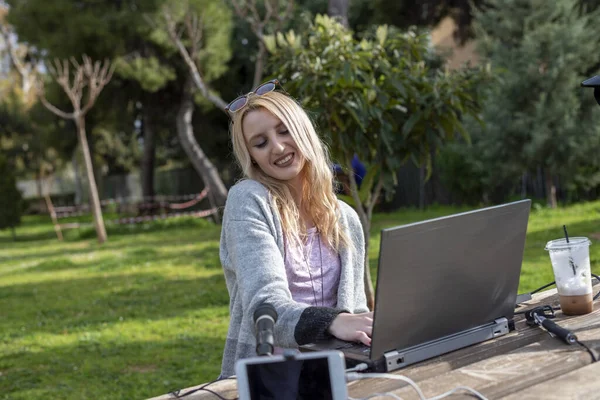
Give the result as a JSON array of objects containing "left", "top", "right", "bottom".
[{"left": 220, "top": 180, "right": 368, "bottom": 378}]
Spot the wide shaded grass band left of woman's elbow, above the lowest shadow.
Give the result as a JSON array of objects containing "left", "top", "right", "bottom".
[{"left": 0, "top": 273, "right": 229, "bottom": 340}]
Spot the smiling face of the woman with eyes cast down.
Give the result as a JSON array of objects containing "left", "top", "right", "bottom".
[{"left": 242, "top": 108, "right": 305, "bottom": 185}]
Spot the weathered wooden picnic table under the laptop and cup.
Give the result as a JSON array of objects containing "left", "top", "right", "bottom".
[{"left": 153, "top": 285, "right": 600, "bottom": 400}]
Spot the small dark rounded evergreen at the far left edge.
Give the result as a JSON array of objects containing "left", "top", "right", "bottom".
[{"left": 0, "top": 154, "right": 23, "bottom": 238}]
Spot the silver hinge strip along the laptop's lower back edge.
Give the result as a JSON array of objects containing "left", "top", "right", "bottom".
[{"left": 383, "top": 318, "right": 509, "bottom": 371}]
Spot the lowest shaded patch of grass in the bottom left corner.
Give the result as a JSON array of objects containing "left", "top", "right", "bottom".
[{"left": 0, "top": 331, "right": 224, "bottom": 400}]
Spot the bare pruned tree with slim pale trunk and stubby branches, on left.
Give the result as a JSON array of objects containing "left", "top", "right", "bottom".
[{"left": 39, "top": 55, "right": 114, "bottom": 244}]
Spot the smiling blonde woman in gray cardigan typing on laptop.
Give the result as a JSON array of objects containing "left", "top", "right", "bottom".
[{"left": 220, "top": 81, "right": 373, "bottom": 377}]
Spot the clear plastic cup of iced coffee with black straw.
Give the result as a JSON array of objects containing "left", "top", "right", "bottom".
[{"left": 546, "top": 237, "right": 593, "bottom": 315}]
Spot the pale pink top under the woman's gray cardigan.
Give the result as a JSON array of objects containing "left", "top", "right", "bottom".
[{"left": 285, "top": 227, "right": 341, "bottom": 307}]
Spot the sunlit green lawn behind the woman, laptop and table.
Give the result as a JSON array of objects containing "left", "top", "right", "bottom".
[{"left": 0, "top": 202, "right": 600, "bottom": 400}]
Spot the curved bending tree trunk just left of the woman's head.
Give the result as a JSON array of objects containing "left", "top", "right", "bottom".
[{"left": 177, "top": 77, "right": 227, "bottom": 206}]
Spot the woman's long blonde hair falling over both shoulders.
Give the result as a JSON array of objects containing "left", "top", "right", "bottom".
[{"left": 231, "top": 91, "right": 352, "bottom": 250}]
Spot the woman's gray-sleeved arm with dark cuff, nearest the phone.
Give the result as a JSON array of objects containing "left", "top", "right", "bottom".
[{"left": 222, "top": 182, "right": 340, "bottom": 347}]
